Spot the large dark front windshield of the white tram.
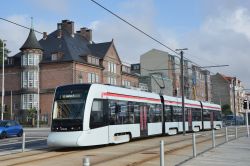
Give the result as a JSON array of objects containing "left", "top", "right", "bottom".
[{"left": 52, "top": 85, "right": 90, "bottom": 131}]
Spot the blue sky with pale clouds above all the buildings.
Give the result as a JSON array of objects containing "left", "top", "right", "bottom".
[{"left": 0, "top": 0, "right": 250, "bottom": 88}]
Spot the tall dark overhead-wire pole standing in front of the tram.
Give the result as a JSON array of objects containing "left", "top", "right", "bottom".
[{"left": 176, "top": 48, "right": 187, "bottom": 135}]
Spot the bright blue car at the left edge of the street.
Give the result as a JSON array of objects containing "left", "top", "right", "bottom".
[{"left": 0, "top": 120, "right": 23, "bottom": 138}]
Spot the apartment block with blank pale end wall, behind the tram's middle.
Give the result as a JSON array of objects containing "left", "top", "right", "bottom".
[{"left": 137, "top": 49, "right": 211, "bottom": 101}]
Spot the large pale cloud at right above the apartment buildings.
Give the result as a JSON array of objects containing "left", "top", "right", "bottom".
[{"left": 184, "top": 7, "right": 250, "bottom": 87}]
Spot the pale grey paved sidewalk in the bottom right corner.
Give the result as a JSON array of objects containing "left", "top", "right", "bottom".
[{"left": 183, "top": 137, "right": 250, "bottom": 166}]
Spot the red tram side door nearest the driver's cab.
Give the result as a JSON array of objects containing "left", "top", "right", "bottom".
[{"left": 140, "top": 105, "right": 148, "bottom": 137}]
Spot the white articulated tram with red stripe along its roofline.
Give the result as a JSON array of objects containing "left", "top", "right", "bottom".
[{"left": 47, "top": 84, "right": 222, "bottom": 147}]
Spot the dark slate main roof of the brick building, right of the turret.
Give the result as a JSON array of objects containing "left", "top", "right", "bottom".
[{"left": 15, "top": 30, "right": 112, "bottom": 62}]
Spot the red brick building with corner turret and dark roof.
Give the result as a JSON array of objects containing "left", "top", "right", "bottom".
[{"left": 0, "top": 20, "right": 138, "bottom": 121}]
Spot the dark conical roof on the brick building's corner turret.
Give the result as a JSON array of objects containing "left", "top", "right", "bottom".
[{"left": 20, "top": 29, "right": 43, "bottom": 50}]
